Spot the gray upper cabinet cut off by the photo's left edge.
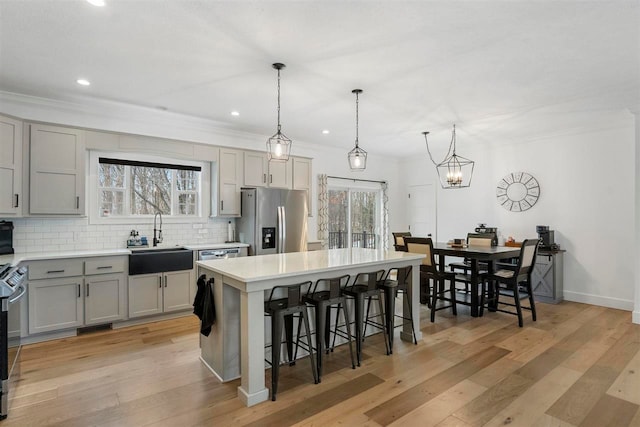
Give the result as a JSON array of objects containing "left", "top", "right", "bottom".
[{"left": 0, "top": 116, "right": 22, "bottom": 216}]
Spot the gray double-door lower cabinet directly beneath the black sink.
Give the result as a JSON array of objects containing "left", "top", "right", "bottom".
[{"left": 129, "top": 270, "right": 193, "bottom": 318}]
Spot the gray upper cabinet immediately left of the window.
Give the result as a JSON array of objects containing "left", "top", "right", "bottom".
[{"left": 29, "top": 124, "right": 86, "bottom": 215}]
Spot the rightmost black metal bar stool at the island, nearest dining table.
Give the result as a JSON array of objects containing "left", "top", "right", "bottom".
[{"left": 364, "top": 266, "right": 418, "bottom": 354}]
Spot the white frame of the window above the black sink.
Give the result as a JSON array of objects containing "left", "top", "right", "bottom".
[{"left": 87, "top": 150, "right": 211, "bottom": 225}]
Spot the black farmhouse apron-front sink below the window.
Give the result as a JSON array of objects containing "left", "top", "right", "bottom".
[{"left": 129, "top": 247, "right": 193, "bottom": 276}]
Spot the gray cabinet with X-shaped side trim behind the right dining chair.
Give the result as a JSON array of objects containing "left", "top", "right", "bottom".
[{"left": 531, "top": 251, "right": 564, "bottom": 304}]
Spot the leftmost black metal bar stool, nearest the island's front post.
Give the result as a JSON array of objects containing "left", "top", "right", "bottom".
[{"left": 264, "top": 282, "right": 318, "bottom": 401}]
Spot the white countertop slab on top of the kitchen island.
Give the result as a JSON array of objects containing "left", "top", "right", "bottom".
[{"left": 196, "top": 248, "right": 424, "bottom": 283}]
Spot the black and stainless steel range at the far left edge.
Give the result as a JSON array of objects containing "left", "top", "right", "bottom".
[{"left": 0, "top": 264, "right": 27, "bottom": 420}]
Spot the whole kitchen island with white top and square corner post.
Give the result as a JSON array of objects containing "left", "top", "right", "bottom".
[{"left": 197, "top": 248, "right": 424, "bottom": 406}]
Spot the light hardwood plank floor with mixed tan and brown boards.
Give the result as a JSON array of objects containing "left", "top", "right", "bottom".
[{"left": 2, "top": 302, "right": 640, "bottom": 427}]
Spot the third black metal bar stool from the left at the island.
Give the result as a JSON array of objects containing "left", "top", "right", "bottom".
[{"left": 336, "top": 270, "right": 390, "bottom": 366}]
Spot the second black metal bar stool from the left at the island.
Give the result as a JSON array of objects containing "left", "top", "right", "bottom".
[{"left": 298, "top": 274, "right": 356, "bottom": 382}]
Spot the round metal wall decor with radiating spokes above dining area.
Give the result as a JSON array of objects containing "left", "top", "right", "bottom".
[{"left": 496, "top": 172, "right": 540, "bottom": 212}]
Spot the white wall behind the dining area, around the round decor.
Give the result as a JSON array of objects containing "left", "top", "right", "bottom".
[{"left": 403, "top": 112, "right": 635, "bottom": 310}]
